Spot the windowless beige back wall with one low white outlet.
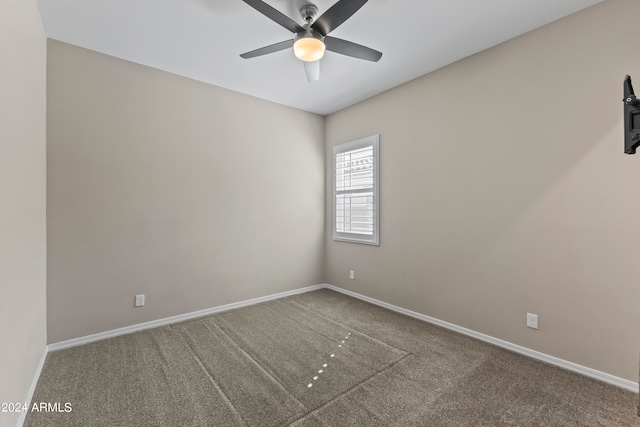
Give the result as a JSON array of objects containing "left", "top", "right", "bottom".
[{"left": 47, "top": 40, "right": 324, "bottom": 342}]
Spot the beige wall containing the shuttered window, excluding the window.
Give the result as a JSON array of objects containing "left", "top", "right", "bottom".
[{"left": 325, "top": 0, "right": 640, "bottom": 381}]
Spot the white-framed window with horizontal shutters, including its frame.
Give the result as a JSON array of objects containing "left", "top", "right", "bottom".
[{"left": 333, "top": 135, "right": 380, "bottom": 245}]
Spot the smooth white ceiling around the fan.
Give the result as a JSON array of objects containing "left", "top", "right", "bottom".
[{"left": 39, "top": 0, "right": 602, "bottom": 115}]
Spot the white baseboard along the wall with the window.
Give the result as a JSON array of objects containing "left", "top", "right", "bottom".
[{"left": 324, "top": 284, "right": 638, "bottom": 393}]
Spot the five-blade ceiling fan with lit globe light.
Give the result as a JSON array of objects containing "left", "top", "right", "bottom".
[{"left": 240, "top": 0, "right": 382, "bottom": 82}]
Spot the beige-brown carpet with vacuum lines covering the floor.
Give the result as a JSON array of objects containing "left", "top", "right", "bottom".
[{"left": 25, "top": 290, "right": 640, "bottom": 427}]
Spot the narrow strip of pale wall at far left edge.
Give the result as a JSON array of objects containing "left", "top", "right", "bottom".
[{"left": 0, "top": 0, "right": 47, "bottom": 426}]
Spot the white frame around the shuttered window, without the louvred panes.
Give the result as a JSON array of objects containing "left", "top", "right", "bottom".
[{"left": 332, "top": 135, "right": 380, "bottom": 246}]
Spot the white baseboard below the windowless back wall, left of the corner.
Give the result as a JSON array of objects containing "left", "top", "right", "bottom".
[{"left": 47, "top": 285, "right": 325, "bottom": 351}]
